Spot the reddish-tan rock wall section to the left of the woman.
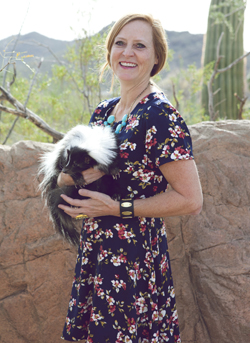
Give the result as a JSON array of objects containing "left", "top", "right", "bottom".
[{"left": 0, "top": 141, "right": 77, "bottom": 343}]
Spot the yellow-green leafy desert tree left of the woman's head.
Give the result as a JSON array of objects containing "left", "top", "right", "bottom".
[{"left": 0, "top": 31, "right": 108, "bottom": 144}]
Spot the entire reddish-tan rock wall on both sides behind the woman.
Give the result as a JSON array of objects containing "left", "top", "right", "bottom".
[{"left": 0, "top": 121, "right": 250, "bottom": 343}]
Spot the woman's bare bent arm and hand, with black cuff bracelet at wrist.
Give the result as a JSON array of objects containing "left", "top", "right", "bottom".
[{"left": 59, "top": 160, "right": 203, "bottom": 217}]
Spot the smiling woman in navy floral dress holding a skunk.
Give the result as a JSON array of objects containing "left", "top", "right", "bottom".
[{"left": 58, "top": 14, "right": 202, "bottom": 343}]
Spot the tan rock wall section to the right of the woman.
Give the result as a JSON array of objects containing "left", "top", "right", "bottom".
[{"left": 166, "top": 121, "right": 250, "bottom": 343}]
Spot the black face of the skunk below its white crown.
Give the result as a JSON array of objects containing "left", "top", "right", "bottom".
[{"left": 62, "top": 147, "right": 97, "bottom": 174}]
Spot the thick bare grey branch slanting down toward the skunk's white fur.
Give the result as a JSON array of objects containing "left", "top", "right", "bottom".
[{"left": 0, "top": 86, "right": 64, "bottom": 141}]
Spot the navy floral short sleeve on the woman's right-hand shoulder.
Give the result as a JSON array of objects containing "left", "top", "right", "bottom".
[{"left": 144, "top": 100, "right": 193, "bottom": 167}]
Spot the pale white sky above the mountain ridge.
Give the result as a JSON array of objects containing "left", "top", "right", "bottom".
[{"left": 0, "top": 0, "right": 250, "bottom": 51}]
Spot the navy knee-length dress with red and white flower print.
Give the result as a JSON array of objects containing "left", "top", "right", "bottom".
[{"left": 62, "top": 93, "right": 193, "bottom": 343}]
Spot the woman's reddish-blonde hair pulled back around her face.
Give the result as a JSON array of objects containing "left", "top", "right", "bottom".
[{"left": 100, "top": 14, "right": 168, "bottom": 87}]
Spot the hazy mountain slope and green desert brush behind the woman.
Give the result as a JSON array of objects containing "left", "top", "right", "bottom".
[{"left": 0, "top": 28, "right": 250, "bottom": 144}]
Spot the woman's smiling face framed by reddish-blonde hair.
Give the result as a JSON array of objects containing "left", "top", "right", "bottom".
[{"left": 110, "top": 20, "right": 158, "bottom": 84}]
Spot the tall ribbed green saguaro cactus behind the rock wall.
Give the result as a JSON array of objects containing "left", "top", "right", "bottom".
[{"left": 202, "top": 0, "right": 245, "bottom": 119}]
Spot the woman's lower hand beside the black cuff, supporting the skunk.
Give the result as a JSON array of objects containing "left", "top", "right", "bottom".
[{"left": 58, "top": 189, "right": 120, "bottom": 218}]
